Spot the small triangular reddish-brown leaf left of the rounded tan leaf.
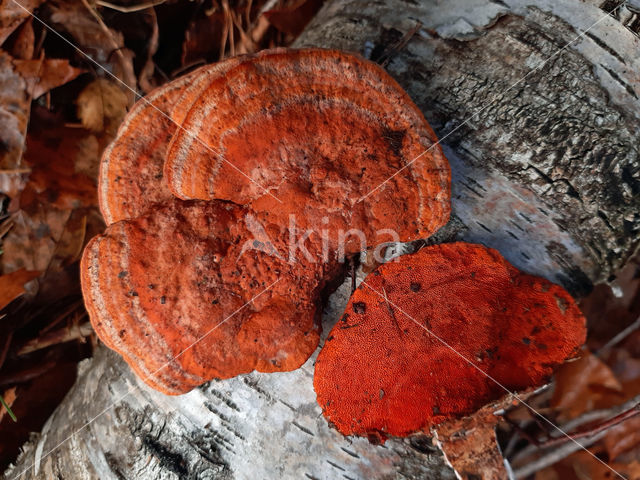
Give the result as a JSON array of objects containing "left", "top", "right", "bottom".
[{"left": 13, "top": 59, "right": 85, "bottom": 100}]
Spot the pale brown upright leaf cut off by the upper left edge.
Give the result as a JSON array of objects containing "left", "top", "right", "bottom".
[{"left": 0, "top": 51, "right": 30, "bottom": 170}]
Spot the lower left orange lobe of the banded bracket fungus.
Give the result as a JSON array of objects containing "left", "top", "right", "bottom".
[{"left": 81, "top": 200, "right": 335, "bottom": 394}]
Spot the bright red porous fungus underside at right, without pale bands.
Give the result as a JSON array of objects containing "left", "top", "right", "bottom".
[{"left": 314, "top": 243, "right": 585, "bottom": 439}]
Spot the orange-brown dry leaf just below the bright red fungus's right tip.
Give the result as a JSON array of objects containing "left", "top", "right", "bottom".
[{"left": 551, "top": 350, "right": 624, "bottom": 420}]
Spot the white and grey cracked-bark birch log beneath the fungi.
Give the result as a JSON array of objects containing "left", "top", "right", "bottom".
[{"left": 7, "top": 0, "right": 640, "bottom": 479}]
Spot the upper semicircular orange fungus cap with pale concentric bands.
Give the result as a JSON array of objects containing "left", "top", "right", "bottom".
[{"left": 165, "top": 49, "right": 450, "bottom": 253}]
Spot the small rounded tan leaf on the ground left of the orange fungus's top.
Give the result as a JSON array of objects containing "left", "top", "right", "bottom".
[{"left": 76, "top": 78, "right": 128, "bottom": 132}]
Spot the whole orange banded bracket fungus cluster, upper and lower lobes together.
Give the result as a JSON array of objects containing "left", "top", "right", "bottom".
[{"left": 81, "top": 49, "right": 450, "bottom": 394}]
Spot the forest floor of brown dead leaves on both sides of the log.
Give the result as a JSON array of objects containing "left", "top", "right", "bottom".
[{"left": 0, "top": 0, "right": 640, "bottom": 480}]
